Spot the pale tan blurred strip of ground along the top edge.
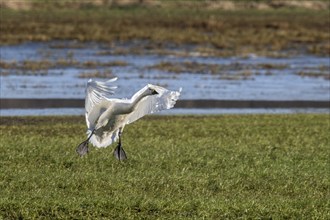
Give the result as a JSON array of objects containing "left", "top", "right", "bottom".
[{"left": 0, "top": 0, "right": 330, "bottom": 10}]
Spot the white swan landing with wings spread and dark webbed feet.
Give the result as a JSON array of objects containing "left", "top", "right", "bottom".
[{"left": 76, "top": 78, "right": 182, "bottom": 160}]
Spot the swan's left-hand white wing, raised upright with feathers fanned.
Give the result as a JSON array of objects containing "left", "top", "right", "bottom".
[{"left": 85, "top": 77, "right": 117, "bottom": 128}]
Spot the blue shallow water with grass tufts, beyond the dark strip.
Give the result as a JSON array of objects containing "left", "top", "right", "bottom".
[{"left": 0, "top": 42, "right": 330, "bottom": 114}]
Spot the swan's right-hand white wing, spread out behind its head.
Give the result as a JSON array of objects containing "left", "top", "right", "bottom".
[{"left": 125, "top": 84, "right": 182, "bottom": 124}]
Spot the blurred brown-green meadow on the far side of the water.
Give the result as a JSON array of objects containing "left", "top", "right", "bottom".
[{"left": 0, "top": 4, "right": 330, "bottom": 56}]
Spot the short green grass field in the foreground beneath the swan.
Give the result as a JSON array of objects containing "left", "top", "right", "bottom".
[{"left": 0, "top": 114, "right": 330, "bottom": 219}]
